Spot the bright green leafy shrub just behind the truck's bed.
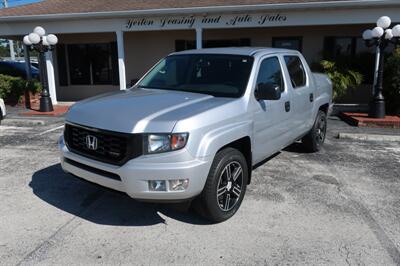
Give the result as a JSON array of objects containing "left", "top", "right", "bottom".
[{"left": 320, "top": 60, "right": 363, "bottom": 100}]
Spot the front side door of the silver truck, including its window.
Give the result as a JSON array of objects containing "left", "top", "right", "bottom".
[{"left": 253, "top": 56, "right": 291, "bottom": 163}]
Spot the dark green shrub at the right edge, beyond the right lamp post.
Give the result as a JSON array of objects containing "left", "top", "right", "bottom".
[{"left": 383, "top": 48, "right": 400, "bottom": 114}]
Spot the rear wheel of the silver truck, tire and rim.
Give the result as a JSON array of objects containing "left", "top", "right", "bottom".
[{"left": 301, "top": 110, "right": 327, "bottom": 152}]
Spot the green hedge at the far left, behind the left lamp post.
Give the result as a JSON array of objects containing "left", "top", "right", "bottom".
[{"left": 0, "top": 74, "right": 41, "bottom": 102}]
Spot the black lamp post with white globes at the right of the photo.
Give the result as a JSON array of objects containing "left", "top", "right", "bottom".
[{"left": 362, "top": 16, "right": 400, "bottom": 118}]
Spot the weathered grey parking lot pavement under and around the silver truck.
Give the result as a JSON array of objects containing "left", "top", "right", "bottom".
[{"left": 0, "top": 120, "right": 400, "bottom": 265}]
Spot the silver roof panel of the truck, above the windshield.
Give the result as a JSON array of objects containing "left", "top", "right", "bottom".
[{"left": 172, "top": 47, "right": 296, "bottom": 56}]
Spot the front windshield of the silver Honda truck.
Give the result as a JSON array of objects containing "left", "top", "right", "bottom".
[{"left": 138, "top": 54, "right": 254, "bottom": 98}]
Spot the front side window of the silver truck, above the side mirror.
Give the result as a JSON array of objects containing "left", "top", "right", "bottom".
[{"left": 257, "top": 57, "right": 285, "bottom": 92}]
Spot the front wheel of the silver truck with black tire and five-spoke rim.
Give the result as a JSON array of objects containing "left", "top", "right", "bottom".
[{"left": 196, "top": 148, "right": 248, "bottom": 222}]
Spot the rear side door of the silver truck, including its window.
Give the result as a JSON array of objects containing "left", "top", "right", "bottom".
[{"left": 283, "top": 54, "right": 315, "bottom": 138}]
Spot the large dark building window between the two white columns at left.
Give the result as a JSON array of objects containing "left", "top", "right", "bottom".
[{"left": 57, "top": 43, "right": 118, "bottom": 86}]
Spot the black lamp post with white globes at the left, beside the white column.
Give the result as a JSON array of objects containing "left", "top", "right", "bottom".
[{"left": 23, "top": 26, "right": 58, "bottom": 112}]
